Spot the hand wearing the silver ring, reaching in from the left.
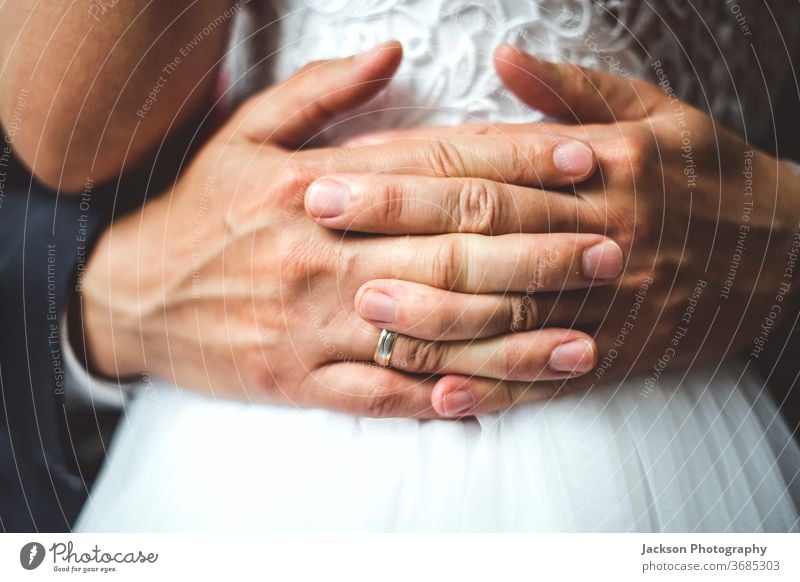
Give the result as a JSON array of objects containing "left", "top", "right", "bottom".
[{"left": 84, "top": 43, "right": 621, "bottom": 416}]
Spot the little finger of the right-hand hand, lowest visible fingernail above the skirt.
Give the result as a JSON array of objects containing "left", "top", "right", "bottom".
[{"left": 431, "top": 375, "right": 574, "bottom": 418}]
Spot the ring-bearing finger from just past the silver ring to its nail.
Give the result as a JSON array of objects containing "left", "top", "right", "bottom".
[{"left": 389, "top": 328, "right": 597, "bottom": 382}]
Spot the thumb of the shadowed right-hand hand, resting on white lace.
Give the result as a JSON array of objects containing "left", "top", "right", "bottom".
[{"left": 494, "top": 45, "right": 665, "bottom": 123}]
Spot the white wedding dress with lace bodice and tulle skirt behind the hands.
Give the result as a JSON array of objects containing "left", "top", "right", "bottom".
[{"left": 77, "top": 0, "right": 800, "bottom": 532}]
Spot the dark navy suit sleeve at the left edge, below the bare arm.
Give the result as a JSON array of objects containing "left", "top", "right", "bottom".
[{"left": 0, "top": 149, "right": 113, "bottom": 531}]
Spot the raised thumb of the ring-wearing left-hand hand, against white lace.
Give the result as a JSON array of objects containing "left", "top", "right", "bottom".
[{"left": 231, "top": 41, "right": 403, "bottom": 149}]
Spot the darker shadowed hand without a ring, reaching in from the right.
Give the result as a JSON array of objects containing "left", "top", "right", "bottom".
[{"left": 314, "top": 47, "right": 800, "bottom": 413}]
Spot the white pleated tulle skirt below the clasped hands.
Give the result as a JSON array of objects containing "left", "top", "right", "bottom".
[{"left": 77, "top": 367, "right": 800, "bottom": 532}]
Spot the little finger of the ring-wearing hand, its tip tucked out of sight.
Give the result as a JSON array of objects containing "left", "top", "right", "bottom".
[{"left": 306, "top": 362, "right": 440, "bottom": 418}]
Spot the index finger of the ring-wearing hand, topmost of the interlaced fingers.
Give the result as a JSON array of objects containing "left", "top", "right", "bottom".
[{"left": 310, "top": 132, "right": 597, "bottom": 187}]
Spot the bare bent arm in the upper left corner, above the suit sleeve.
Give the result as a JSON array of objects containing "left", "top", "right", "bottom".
[{"left": 0, "top": 0, "right": 236, "bottom": 191}]
